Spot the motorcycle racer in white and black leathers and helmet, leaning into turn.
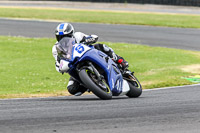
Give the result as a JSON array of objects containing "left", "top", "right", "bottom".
[{"left": 52, "top": 23, "right": 128, "bottom": 96}]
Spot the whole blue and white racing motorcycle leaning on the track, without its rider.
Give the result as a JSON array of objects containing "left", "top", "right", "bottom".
[{"left": 59, "top": 39, "right": 142, "bottom": 99}]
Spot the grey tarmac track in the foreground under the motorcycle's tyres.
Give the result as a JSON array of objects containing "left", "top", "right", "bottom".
[{"left": 0, "top": 86, "right": 200, "bottom": 133}]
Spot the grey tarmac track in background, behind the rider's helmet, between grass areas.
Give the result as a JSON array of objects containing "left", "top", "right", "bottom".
[{"left": 0, "top": 18, "right": 200, "bottom": 50}]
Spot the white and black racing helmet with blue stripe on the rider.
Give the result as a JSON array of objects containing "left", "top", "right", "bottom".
[{"left": 55, "top": 23, "right": 74, "bottom": 41}]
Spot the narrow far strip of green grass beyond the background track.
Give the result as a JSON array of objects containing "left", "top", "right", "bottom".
[{"left": 0, "top": 7, "right": 200, "bottom": 28}]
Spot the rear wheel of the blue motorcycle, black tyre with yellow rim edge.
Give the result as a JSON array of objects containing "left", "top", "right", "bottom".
[{"left": 126, "top": 75, "right": 142, "bottom": 98}]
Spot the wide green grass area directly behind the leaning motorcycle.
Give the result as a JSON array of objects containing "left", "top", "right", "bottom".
[{"left": 0, "top": 36, "right": 200, "bottom": 98}]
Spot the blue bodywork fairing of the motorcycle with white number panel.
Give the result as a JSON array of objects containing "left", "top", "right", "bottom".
[{"left": 68, "top": 44, "right": 123, "bottom": 96}]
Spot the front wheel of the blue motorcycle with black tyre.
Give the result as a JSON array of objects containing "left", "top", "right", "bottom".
[{"left": 79, "top": 69, "right": 112, "bottom": 100}]
